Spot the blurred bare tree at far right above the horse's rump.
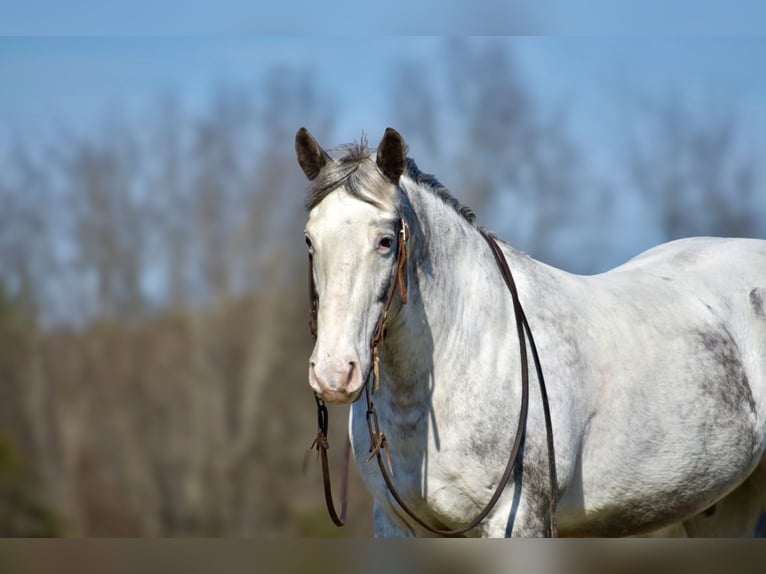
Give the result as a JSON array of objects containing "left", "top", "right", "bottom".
[{"left": 627, "top": 95, "right": 766, "bottom": 239}]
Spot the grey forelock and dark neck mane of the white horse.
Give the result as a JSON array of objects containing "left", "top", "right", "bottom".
[{"left": 306, "top": 140, "right": 476, "bottom": 225}]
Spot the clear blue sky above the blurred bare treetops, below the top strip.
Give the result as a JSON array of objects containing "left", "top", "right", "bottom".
[{"left": 0, "top": 36, "right": 766, "bottom": 177}]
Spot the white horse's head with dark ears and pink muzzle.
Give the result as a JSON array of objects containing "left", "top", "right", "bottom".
[{"left": 295, "top": 128, "right": 407, "bottom": 403}]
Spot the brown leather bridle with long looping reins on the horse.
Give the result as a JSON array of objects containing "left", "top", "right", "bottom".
[{"left": 309, "top": 208, "right": 558, "bottom": 537}]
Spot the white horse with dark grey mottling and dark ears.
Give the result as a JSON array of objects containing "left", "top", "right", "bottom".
[{"left": 295, "top": 128, "right": 766, "bottom": 537}]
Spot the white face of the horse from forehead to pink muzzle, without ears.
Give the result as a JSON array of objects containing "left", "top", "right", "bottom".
[{"left": 306, "top": 189, "right": 397, "bottom": 403}]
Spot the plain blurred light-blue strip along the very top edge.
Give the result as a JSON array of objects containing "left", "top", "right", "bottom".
[{"left": 0, "top": 0, "right": 766, "bottom": 36}]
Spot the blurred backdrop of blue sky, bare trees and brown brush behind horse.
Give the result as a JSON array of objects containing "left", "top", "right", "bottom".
[{"left": 0, "top": 37, "right": 766, "bottom": 537}]
